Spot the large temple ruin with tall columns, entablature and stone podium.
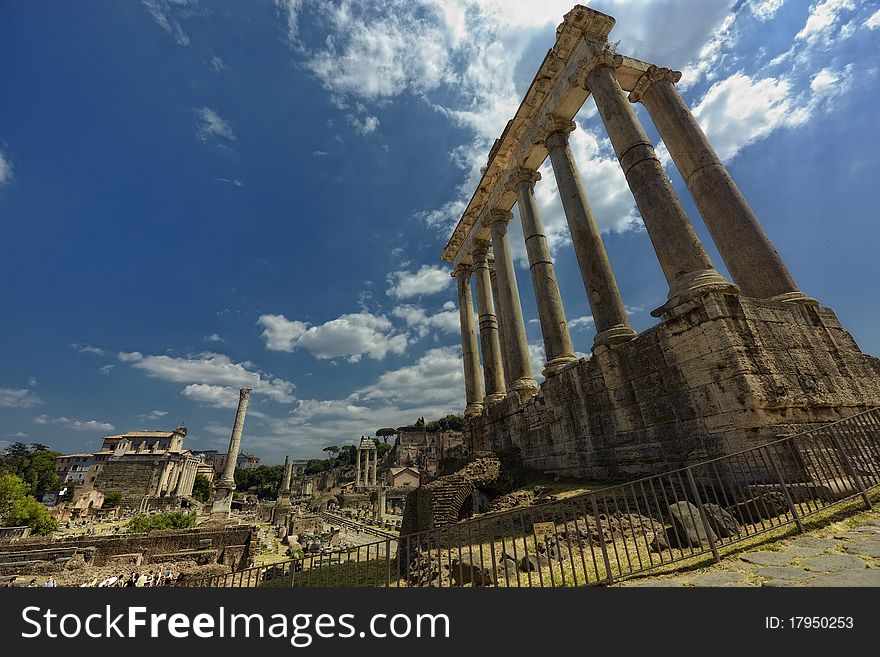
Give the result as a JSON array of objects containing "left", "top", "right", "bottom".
[{"left": 443, "top": 5, "right": 880, "bottom": 480}]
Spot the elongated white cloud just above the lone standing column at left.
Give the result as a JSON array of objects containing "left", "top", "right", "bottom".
[{"left": 119, "top": 352, "right": 294, "bottom": 403}]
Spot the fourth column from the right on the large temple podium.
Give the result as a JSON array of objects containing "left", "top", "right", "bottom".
[{"left": 509, "top": 169, "right": 575, "bottom": 378}]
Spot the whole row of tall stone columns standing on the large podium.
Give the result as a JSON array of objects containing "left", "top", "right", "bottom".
[{"left": 454, "top": 49, "right": 812, "bottom": 415}]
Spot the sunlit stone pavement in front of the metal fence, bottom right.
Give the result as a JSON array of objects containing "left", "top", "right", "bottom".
[{"left": 620, "top": 512, "right": 880, "bottom": 586}]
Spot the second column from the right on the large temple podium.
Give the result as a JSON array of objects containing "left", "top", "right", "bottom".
[{"left": 586, "top": 51, "right": 736, "bottom": 316}]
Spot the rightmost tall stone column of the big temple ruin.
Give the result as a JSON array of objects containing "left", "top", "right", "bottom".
[{"left": 629, "top": 66, "right": 812, "bottom": 301}]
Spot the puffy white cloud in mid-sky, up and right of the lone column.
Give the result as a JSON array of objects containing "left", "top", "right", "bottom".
[{"left": 259, "top": 311, "right": 407, "bottom": 362}]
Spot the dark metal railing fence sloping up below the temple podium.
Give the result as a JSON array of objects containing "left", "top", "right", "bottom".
[{"left": 186, "top": 409, "right": 880, "bottom": 587}]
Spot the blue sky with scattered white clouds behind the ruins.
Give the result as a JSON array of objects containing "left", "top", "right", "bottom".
[{"left": 0, "top": 0, "right": 880, "bottom": 462}]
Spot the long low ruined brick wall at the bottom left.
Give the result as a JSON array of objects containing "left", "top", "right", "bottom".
[{"left": 0, "top": 525, "right": 256, "bottom": 568}]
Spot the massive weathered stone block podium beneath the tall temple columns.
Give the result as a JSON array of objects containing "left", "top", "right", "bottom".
[{"left": 467, "top": 294, "right": 880, "bottom": 480}]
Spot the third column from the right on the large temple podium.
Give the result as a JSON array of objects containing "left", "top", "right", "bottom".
[{"left": 544, "top": 121, "right": 636, "bottom": 348}]
